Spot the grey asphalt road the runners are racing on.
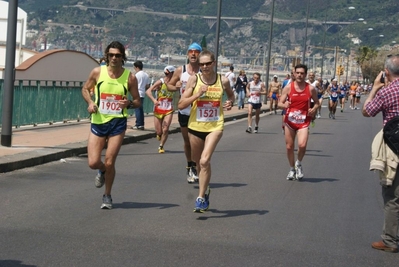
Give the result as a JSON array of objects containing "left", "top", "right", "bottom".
[{"left": 0, "top": 109, "right": 398, "bottom": 267}]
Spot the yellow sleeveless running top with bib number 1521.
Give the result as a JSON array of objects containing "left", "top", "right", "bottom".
[{"left": 188, "top": 74, "right": 224, "bottom": 132}]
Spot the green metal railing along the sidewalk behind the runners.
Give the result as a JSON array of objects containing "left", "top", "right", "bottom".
[{"left": 0, "top": 79, "right": 161, "bottom": 128}]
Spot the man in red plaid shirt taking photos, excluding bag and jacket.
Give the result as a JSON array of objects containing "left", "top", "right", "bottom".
[{"left": 362, "top": 55, "right": 399, "bottom": 253}]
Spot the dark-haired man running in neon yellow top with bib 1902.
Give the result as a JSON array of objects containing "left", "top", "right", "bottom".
[{"left": 82, "top": 42, "right": 141, "bottom": 209}]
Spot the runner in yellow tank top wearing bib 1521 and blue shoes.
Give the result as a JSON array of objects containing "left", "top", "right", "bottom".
[{"left": 178, "top": 50, "right": 235, "bottom": 212}]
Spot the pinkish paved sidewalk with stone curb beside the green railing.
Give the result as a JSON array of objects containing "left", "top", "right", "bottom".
[{"left": 0, "top": 107, "right": 262, "bottom": 173}]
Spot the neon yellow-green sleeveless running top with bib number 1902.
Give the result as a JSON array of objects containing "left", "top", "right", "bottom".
[{"left": 91, "top": 66, "right": 130, "bottom": 124}]
